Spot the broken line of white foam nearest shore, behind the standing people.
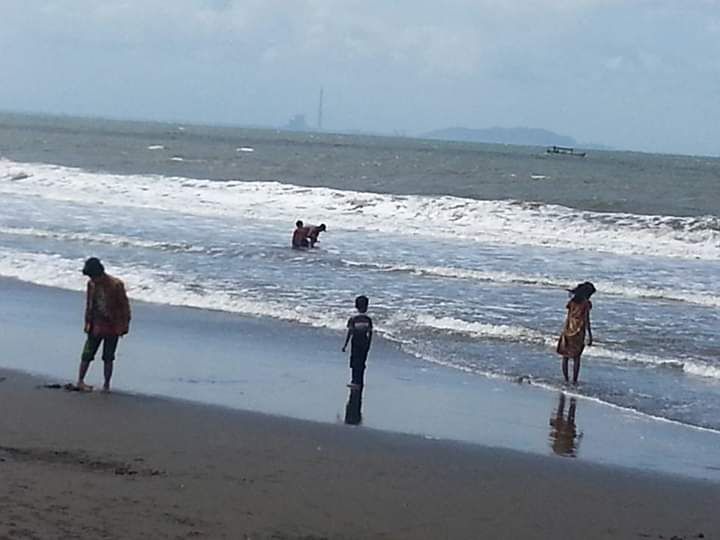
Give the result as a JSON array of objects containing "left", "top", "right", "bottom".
[{"left": 0, "top": 249, "right": 720, "bottom": 388}]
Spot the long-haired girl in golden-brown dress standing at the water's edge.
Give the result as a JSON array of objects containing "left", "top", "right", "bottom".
[{"left": 557, "top": 281, "right": 595, "bottom": 384}]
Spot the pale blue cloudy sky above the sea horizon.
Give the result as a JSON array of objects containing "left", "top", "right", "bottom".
[{"left": 0, "top": 0, "right": 720, "bottom": 155}]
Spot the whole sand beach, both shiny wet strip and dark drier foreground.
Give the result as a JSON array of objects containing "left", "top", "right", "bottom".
[{"left": 0, "top": 280, "right": 720, "bottom": 539}]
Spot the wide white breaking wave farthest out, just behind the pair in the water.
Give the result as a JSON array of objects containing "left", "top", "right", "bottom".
[{"left": 0, "top": 160, "right": 720, "bottom": 260}]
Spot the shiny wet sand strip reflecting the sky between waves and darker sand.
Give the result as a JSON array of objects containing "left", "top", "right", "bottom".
[{"left": 0, "top": 278, "right": 720, "bottom": 482}]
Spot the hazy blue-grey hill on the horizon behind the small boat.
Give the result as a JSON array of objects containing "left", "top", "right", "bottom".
[{"left": 422, "top": 127, "right": 578, "bottom": 146}]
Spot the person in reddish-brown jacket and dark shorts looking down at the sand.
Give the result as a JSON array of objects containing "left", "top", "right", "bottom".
[{"left": 77, "top": 257, "right": 130, "bottom": 392}]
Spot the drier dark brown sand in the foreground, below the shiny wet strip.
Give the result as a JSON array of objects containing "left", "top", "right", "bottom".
[{"left": 0, "top": 371, "right": 720, "bottom": 539}]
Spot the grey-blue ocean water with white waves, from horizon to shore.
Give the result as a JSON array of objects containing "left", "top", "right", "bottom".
[{"left": 0, "top": 116, "right": 720, "bottom": 430}]
